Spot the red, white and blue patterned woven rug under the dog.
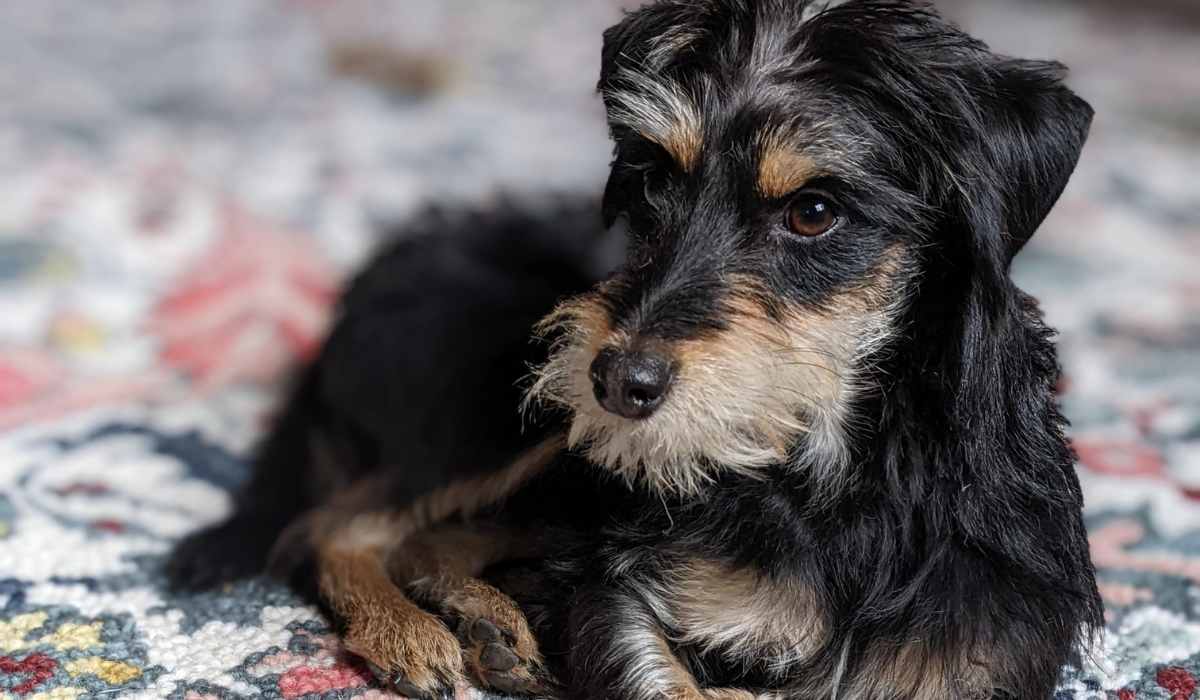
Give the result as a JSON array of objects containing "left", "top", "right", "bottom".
[{"left": 0, "top": 0, "right": 1200, "bottom": 700}]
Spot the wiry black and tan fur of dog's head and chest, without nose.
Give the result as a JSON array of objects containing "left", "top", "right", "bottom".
[{"left": 514, "top": 0, "right": 1100, "bottom": 700}]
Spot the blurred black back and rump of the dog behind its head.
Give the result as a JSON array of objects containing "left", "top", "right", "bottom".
[{"left": 170, "top": 202, "right": 624, "bottom": 588}]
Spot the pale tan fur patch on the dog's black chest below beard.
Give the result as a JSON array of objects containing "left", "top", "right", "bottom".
[{"left": 670, "top": 560, "right": 828, "bottom": 671}]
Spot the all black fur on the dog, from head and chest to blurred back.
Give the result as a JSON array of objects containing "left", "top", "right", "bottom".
[{"left": 178, "top": 0, "right": 1102, "bottom": 700}]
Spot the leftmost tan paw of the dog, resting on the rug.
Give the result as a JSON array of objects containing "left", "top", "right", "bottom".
[{"left": 343, "top": 608, "right": 462, "bottom": 700}]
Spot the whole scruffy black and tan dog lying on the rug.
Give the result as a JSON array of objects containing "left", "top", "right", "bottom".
[{"left": 164, "top": 0, "right": 1102, "bottom": 700}]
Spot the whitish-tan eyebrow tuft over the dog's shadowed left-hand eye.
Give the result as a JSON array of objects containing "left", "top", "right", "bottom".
[{"left": 605, "top": 70, "right": 704, "bottom": 173}]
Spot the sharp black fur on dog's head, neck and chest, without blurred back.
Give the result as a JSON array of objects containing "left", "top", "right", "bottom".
[{"left": 520, "top": 0, "right": 1102, "bottom": 700}]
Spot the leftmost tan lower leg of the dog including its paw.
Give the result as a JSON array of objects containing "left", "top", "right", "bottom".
[{"left": 318, "top": 546, "right": 462, "bottom": 693}]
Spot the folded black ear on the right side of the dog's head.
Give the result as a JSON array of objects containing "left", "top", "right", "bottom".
[{"left": 952, "top": 59, "right": 1092, "bottom": 267}]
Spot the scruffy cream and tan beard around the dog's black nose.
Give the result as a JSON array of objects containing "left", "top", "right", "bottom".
[{"left": 526, "top": 273, "right": 890, "bottom": 495}]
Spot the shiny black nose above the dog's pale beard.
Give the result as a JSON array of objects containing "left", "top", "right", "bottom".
[{"left": 588, "top": 348, "right": 674, "bottom": 419}]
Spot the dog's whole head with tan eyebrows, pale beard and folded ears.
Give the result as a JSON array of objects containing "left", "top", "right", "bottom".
[{"left": 530, "top": 0, "right": 1091, "bottom": 491}]
